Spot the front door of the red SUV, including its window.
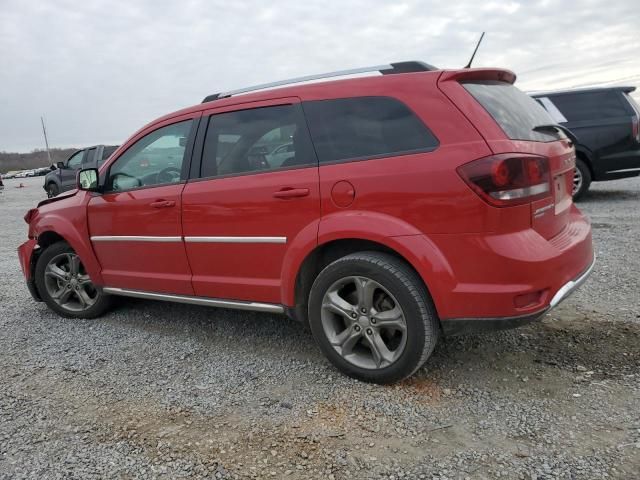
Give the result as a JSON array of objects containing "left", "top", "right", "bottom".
[{"left": 88, "top": 114, "right": 199, "bottom": 295}]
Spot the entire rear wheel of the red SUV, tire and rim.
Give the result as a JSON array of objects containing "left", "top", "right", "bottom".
[{"left": 309, "top": 252, "right": 440, "bottom": 384}]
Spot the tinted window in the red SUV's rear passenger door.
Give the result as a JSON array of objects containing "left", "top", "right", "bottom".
[{"left": 201, "top": 105, "right": 316, "bottom": 177}]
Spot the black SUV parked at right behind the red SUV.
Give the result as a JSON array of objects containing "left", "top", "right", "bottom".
[{"left": 531, "top": 87, "right": 640, "bottom": 200}]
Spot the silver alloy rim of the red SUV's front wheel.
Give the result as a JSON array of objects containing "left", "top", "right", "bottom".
[{"left": 44, "top": 253, "right": 99, "bottom": 312}]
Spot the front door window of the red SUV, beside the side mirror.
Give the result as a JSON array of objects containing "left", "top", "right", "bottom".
[{"left": 107, "top": 120, "right": 192, "bottom": 192}]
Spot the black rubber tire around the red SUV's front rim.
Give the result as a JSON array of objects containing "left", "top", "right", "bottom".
[{"left": 35, "top": 242, "right": 112, "bottom": 318}]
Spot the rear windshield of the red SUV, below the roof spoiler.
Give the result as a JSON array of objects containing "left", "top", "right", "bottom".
[{"left": 462, "top": 80, "right": 564, "bottom": 142}]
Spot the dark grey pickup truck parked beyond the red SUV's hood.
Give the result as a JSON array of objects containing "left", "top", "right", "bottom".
[{"left": 42, "top": 145, "right": 118, "bottom": 198}]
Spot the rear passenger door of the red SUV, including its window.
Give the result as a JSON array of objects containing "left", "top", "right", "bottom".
[{"left": 182, "top": 98, "right": 320, "bottom": 303}]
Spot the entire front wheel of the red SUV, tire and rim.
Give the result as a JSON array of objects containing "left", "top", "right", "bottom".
[{"left": 35, "top": 242, "right": 111, "bottom": 318}]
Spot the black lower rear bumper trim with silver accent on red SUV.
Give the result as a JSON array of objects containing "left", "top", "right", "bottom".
[{"left": 442, "top": 258, "right": 596, "bottom": 336}]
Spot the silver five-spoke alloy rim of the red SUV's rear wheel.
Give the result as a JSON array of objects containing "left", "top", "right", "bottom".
[{"left": 321, "top": 276, "right": 407, "bottom": 369}]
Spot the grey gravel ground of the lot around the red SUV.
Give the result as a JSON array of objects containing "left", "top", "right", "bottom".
[{"left": 0, "top": 178, "right": 640, "bottom": 480}]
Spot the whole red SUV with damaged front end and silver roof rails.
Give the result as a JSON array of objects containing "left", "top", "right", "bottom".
[{"left": 19, "top": 62, "right": 594, "bottom": 383}]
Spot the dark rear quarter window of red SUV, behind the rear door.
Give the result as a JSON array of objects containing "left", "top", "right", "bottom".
[{"left": 304, "top": 97, "right": 438, "bottom": 163}]
